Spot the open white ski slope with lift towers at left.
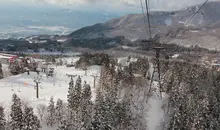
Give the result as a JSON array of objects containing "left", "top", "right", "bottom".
[{"left": 0, "top": 59, "right": 100, "bottom": 108}]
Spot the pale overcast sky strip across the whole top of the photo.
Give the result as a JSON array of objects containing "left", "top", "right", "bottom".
[{"left": 0, "top": 0, "right": 215, "bottom": 12}]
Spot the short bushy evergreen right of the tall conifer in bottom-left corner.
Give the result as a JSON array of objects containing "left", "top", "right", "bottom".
[{"left": 22, "top": 107, "right": 40, "bottom": 130}]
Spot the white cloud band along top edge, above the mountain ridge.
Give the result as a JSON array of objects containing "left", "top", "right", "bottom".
[{"left": 31, "top": 0, "right": 214, "bottom": 10}]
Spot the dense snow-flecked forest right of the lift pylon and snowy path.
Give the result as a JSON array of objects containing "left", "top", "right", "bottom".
[{"left": 157, "top": 61, "right": 220, "bottom": 130}]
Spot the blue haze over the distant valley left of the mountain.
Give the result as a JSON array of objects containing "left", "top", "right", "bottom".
[{"left": 0, "top": 4, "right": 122, "bottom": 38}]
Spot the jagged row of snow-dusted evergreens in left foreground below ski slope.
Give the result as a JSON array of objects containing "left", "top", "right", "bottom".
[{"left": 0, "top": 74, "right": 139, "bottom": 130}]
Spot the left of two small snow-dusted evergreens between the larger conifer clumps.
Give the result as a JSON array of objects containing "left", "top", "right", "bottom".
[{"left": 46, "top": 97, "right": 56, "bottom": 127}]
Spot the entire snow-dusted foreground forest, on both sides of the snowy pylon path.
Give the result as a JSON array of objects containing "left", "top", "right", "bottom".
[{"left": 0, "top": 56, "right": 220, "bottom": 130}]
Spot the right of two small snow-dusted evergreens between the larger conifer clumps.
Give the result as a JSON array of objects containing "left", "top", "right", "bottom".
[{"left": 56, "top": 99, "right": 64, "bottom": 122}]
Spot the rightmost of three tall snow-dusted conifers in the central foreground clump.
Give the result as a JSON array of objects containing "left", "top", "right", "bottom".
[{"left": 81, "top": 83, "right": 92, "bottom": 130}]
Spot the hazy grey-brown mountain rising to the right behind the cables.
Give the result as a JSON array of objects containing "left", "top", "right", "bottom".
[{"left": 70, "top": 2, "right": 220, "bottom": 49}]
